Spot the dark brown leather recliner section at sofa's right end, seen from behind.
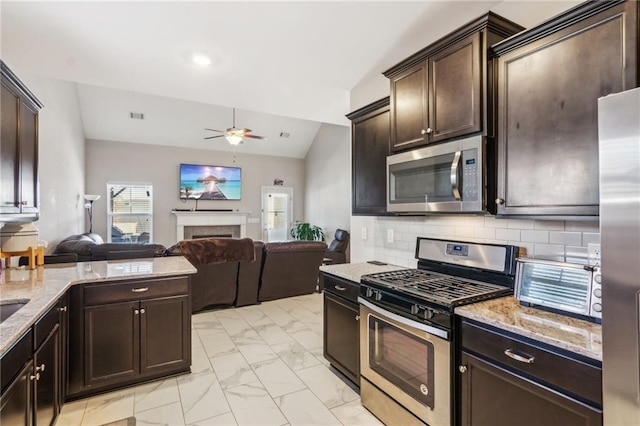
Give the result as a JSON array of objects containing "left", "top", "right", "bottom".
[{"left": 258, "top": 241, "right": 327, "bottom": 302}]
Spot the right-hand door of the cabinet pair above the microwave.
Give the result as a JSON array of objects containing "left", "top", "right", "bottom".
[{"left": 428, "top": 32, "right": 483, "bottom": 142}]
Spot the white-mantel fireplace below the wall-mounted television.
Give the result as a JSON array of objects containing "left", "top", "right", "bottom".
[{"left": 173, "top": 211, "right": 249, "bottom": 241}]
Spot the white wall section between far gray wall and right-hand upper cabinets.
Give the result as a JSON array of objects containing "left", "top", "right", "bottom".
[{"left": 304, "top": 124, "right": 351, "bottom": 244}]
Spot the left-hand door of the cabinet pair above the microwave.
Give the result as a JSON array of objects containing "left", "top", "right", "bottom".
[{"left": 391, "top": 61, "right": 428, "bottom": 151}]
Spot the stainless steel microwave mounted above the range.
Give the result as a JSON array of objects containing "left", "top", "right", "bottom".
[{"left": 387, "top": 136, "right": 484, "bottom": 213}]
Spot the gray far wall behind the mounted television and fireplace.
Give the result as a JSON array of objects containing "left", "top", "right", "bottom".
[{"left": 86, "top": 140, "right": 305, "bottom": 246}]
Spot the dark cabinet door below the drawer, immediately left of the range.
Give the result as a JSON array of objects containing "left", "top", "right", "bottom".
[{"left": 324, "top": 291, "right": 360, "bottom": 385}]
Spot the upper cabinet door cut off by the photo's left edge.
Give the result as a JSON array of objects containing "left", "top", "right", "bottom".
[{"left": 0, "top": 84, "right": 20, "bottom": 213}]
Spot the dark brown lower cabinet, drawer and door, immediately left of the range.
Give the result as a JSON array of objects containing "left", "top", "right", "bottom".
[{"left": 323, "top": 275, "right": 360, "bottom": 386}]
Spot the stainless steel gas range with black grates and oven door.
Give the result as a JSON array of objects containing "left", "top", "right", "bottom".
[{"left": 358, "top": 238, "right": 518, "bottom": 426}]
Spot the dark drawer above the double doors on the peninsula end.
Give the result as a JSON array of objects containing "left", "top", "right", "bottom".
[{"left": 84, "top": 277, "right": 189, "bottom": 306}]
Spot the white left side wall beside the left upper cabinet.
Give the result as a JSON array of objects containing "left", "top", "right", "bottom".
[{"left": 9, "top": 74, "right": 85, "bottom": 253}]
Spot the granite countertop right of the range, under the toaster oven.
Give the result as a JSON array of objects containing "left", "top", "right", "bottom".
[{"left": 455, "top": 296, "right": 602, "bottom": 361}]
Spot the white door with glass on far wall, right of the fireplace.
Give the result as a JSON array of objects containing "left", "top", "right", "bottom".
[{"left": 262, "top": 186, "right": 293, "bottom": 242}]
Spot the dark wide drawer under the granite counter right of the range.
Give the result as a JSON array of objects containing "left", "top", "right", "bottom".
[{"left": 462, "top": 322, "right": 602, "bottom": 407}]
